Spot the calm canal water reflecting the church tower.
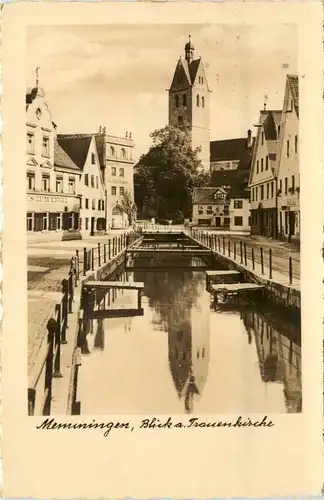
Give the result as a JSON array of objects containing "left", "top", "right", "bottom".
[{"left": 77, "top": 254, "right": 302, "bottom": 414}]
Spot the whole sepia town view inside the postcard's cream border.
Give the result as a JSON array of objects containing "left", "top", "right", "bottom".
[{"left": 26, "top": 24, "right": 302, "bottom": 416}]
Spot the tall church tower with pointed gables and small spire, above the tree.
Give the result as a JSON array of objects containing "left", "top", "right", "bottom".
[{"left": 168, "top": 36, "right": 210, "bottom": 172}]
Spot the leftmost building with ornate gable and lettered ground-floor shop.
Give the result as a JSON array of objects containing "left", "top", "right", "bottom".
[{"left": 26, "top": 82, "right": 80, "bottom": 232}]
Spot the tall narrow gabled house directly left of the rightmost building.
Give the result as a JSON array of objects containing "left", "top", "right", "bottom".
[{"left": 249, "top": 110, "right": 282, "bottom": 238}]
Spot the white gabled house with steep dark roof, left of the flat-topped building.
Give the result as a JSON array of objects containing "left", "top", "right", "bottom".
[{"left": 57, "top": 134, "right": 107, "bottom": 235}]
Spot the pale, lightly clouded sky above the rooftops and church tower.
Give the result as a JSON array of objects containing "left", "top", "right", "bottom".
[{"left": 26, "top": 24, "right": 298, "bottom": 158}]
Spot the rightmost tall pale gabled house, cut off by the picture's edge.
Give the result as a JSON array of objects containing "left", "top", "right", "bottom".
[{"left": 276, "top": 75, "right": 300, "bottom": 241}]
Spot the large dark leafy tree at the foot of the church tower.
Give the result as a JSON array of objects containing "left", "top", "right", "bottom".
[{"left": 134, "top": 126, "right": 206, "bottom": 218}]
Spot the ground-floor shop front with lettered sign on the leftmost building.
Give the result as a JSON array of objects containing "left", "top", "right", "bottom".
[{"left": 26, "top": 194, "right": 80, "bottom": 232}]
